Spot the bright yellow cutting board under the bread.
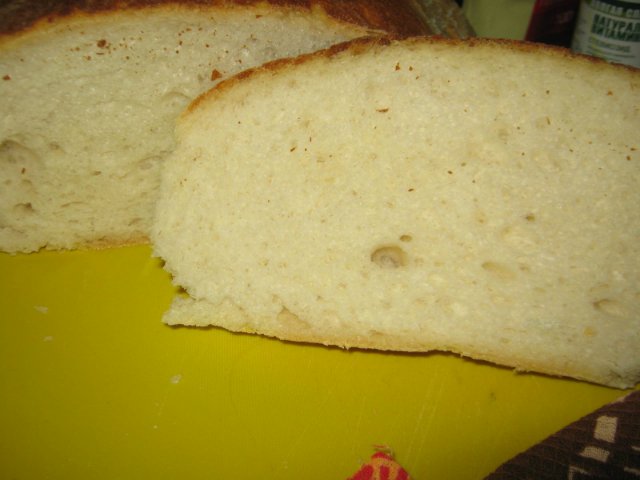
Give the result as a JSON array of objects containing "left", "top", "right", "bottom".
[{"left": 0, "top": 246, "right": 624, "bottom": 480}]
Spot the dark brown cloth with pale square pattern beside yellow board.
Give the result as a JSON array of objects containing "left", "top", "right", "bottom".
[{"left": 485, "top": 391, "right": 640, "bottom": 480}]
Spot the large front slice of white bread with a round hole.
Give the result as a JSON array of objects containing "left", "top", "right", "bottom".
[{"left": 152, "top": 38, "right": 640, "bottom": 387}]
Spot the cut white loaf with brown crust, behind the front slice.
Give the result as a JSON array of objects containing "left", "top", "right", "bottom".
[{"left": 0, "top": 0, "right": 469, "bottom": 252}]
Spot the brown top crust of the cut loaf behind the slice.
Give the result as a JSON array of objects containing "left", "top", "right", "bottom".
[{"left": 0, "top": 0, "right": 473, "bottom": 37}]
